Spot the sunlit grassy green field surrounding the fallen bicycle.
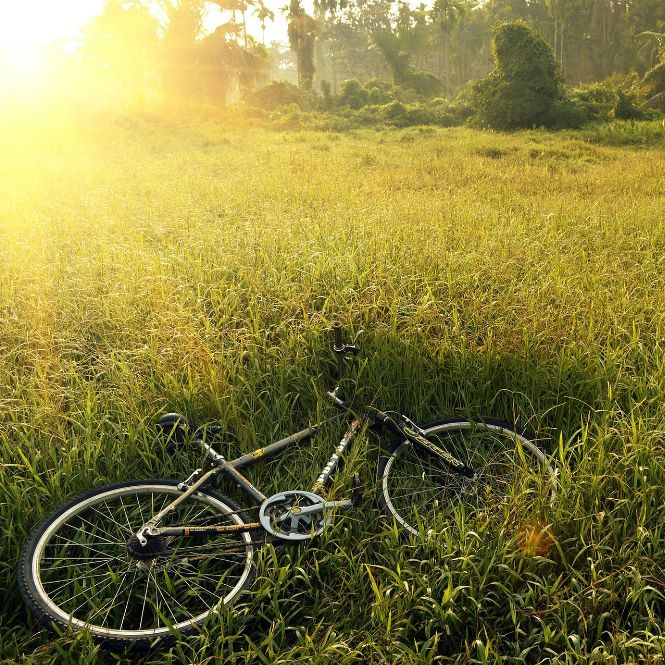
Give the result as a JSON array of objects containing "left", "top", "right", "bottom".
[{"left": 0, "top": 116, "right": 665, "bottom": 663}]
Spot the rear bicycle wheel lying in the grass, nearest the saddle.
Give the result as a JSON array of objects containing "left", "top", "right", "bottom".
[{"left": 19, "top": 480, "right": 255, "bottom": 649}]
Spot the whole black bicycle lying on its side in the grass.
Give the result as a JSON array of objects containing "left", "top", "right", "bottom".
[{"left": 19, "top": 325, "right": 556, "bottom": 649}]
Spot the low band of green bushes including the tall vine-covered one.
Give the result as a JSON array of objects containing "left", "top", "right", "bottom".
[{"left": 239, "top": 20, "right": 663, "bottom": 132}]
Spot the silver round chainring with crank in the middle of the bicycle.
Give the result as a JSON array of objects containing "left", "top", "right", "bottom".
[{"left": 259, "top": 490, "right": 331, "bottom": 540}]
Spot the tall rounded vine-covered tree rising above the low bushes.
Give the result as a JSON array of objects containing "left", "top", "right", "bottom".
[{"left": 472, "top": 21, "right": 561, "bottom": 129}]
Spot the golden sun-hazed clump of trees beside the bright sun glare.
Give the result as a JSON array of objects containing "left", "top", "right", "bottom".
[{"left": 75, "top": 0, "right": 273, "bottom": 105}]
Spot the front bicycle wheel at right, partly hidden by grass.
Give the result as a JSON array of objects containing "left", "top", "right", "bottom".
[{"left": 378, "top": 420, "right": 556, "bottom": 535}]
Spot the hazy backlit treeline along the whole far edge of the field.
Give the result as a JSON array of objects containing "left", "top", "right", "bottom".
[{"left": 52, "top": 0, "right": 665, "bottom": 125}]
